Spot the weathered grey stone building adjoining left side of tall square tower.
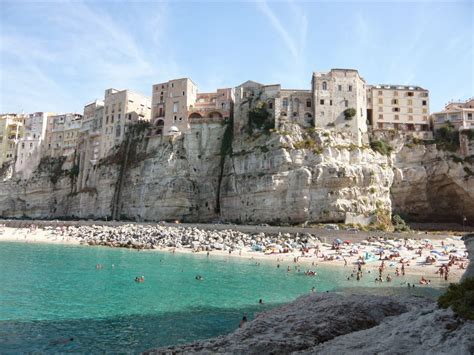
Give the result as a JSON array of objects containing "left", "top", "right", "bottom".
[{"left": 234, "top": 80, "right": 314, "bottom": 135}]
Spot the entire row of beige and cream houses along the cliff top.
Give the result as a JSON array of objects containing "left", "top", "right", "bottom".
[{"left": 0, "top": 69, "right": 474, "bottom": 177}]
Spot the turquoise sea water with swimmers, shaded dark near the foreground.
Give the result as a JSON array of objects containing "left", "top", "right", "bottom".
[{"left": 0, "top": 243, "right": 441, "bottom": 353}]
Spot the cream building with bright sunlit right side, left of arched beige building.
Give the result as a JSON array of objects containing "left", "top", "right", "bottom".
[{"left": 100, "top": 89, "right": 151, "bottom": 157}]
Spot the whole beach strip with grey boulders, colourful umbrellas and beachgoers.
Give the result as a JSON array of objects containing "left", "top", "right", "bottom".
[{"left": 0, "top": 224, "right": 469, "bottom": 284}]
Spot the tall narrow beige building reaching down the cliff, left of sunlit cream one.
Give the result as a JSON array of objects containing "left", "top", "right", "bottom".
[{"left": 77, "top": 100, "right": 104, "bottom": 189}]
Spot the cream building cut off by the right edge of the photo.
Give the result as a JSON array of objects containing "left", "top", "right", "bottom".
[{"left": 431, "top": 98, "right": 474, "bottom": 131}]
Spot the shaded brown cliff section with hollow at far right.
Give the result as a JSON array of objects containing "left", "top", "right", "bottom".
[{"left": 391, "top": 144, "right": 474, "bottom": 225}]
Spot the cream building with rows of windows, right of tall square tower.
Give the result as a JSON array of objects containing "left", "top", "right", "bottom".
[{"left": 367, "top": 85, "right": 433, "bottom": 139}]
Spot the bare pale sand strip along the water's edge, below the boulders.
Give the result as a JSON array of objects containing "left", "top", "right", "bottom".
[{"left": 0, "top": 227, "right": 469, "bottom": 286}]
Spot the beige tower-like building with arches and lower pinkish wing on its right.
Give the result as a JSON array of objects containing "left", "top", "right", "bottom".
[{"left": 152, "top": 78, "right": 233, "bottom": 135}]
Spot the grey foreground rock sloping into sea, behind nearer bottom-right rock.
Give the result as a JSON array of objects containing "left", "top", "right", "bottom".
[{"left": 150, "top": 293, "right": 436, "bottom": 354}]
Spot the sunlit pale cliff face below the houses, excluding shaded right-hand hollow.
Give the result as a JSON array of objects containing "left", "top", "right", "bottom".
[{"left": 0, "top": 122, "right": 393, "bottom": 223}]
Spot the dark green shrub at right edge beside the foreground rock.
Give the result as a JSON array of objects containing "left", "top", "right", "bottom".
[{"left": 438, "top": 277, "right": 474, "bottom": 320}]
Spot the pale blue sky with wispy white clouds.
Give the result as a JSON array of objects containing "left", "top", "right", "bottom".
[{"left": 0, "top": 0, "right": 474, "bottom": 113}]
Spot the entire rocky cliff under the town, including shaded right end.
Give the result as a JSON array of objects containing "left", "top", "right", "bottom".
[{"left": 0, "top": 120, "right": 474, "bottom": 224}]
